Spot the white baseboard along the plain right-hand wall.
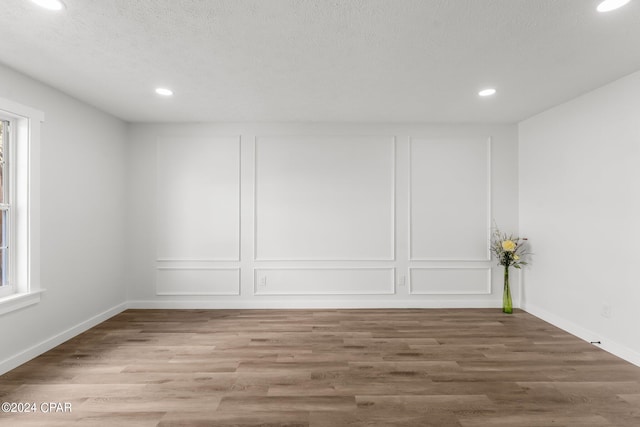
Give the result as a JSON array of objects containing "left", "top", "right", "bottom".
[{"left": 523, "top": 304, "right": 640, "bottom": 366}]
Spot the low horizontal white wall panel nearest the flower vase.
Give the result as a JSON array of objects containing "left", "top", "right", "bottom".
[{"left": 409, "top": 267, "right": 491, "bottom": 295}]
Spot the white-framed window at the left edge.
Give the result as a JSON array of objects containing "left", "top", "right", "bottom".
[{"left": 0, "top": 98, "right": 44, "bottom": 315}]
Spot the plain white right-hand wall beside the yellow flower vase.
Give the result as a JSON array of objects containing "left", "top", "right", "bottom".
[{"left": 519, "top": 72, "right": 640, "bottom": 365}]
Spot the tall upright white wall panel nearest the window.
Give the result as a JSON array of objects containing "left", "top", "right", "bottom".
[{"left": 156, "top": 137, "right": 240, "bottom": 261}]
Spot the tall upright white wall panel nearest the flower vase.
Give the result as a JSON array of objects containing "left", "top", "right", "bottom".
[{"left": 409, "top": 138, "right": 491, "bottom": 261}]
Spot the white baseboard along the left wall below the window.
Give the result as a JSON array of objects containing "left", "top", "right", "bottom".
[{"left": 0, "top": 302, "right": 128, "bottom": 375}]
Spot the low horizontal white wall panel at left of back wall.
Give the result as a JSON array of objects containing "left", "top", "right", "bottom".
[{"left": 156, "top": 267, "right": 240, "bottom": 295}]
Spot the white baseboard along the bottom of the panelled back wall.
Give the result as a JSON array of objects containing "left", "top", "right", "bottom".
[{"left": 128, "top": 298, "right": 502, "bottom": 310}]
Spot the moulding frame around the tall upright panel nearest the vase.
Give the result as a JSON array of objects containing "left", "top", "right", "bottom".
[{"left": 408, "top": 136, "right": 492, "bottom": 261}]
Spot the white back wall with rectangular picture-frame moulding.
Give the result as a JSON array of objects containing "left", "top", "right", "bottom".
[{"left": 127, "top": 124, "right": 518, "bottom": 308}]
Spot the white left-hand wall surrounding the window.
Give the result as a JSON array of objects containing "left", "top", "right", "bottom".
[{"left": 0, "top": 66, "right": 127, "bottom": 372}]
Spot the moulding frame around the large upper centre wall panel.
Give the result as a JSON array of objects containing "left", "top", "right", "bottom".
[{"left": 253, "top": 135, "right": 396, "bottom": 262}]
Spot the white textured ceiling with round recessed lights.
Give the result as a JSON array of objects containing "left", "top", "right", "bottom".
[{"left": 0, "top": 0, "right": 640, "bottom": 123}]
